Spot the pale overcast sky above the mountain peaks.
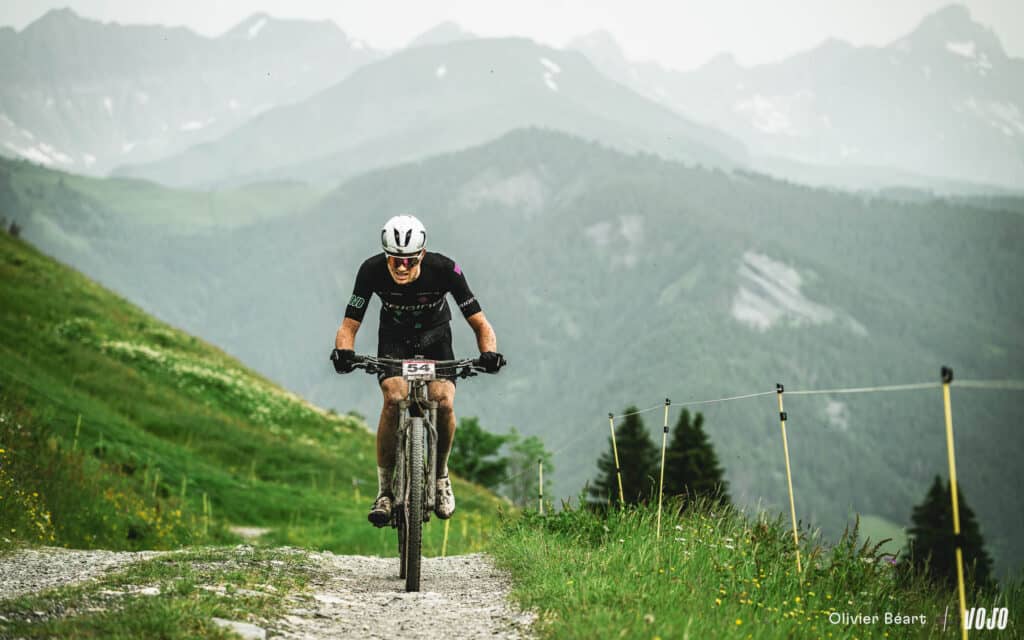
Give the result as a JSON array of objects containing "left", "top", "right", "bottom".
[{"left": 6, "top": 0, "right": 1024, "bottom": 69}]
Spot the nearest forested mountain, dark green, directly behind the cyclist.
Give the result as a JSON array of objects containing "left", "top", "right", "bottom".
[{"left": 0, "top": 131, "right": 1024, "bottom": 566}]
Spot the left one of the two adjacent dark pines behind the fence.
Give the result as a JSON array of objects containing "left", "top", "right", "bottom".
[{"left": 590, "top": 407, "right": 658, "bottom": 505}]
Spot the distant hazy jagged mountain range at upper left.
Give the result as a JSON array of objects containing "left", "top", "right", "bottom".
[{"left": 0, "top": 9, "right": 380, "bottom": 174}]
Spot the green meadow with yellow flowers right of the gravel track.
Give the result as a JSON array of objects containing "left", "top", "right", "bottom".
[{"left": 492, "top": 503, "right": 1024, "bottom": 640}]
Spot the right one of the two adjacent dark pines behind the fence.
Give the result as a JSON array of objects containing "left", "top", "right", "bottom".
[{"left": 665, "top": 409, "right": 729, "bottom": 503}]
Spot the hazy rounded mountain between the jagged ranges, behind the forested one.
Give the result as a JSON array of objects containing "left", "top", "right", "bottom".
[{"left": 119, "top": 38, "right": 746, "bottom": 185}]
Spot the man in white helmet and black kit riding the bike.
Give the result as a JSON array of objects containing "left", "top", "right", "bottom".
[{"left": 331, "top": 215, "right": 505, "bottom": 526}]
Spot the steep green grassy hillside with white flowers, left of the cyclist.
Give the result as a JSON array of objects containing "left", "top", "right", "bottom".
[{"left": 0, "top": 233, "right": 499, "bottom": 555}]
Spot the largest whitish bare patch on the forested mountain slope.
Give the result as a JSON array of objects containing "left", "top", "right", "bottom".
[{"left": 731, "top": 251, "right": 867, "bottom": 335}]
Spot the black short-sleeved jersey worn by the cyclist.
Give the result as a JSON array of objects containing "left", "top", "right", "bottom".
[{"left": 345, "top": 251, "right": 480, "bottom": 334}]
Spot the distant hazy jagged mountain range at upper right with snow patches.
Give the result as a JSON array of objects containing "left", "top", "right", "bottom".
[{"left": 570, "top": 5, "right": 1024, "bottom": 188}]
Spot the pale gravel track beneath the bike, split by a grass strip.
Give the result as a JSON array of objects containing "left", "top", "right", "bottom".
[{"left": 0, "top": 547, "right": 532, "bottom": 640}]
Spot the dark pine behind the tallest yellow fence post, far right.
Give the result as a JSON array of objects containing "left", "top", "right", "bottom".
[{"left": 907, "top": 476, "right": 992, "bottom": 587}]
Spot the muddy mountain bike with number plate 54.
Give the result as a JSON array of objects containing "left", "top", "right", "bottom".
[{"left": 354, "top": 355, "right": 485, "bottom": 591}]
